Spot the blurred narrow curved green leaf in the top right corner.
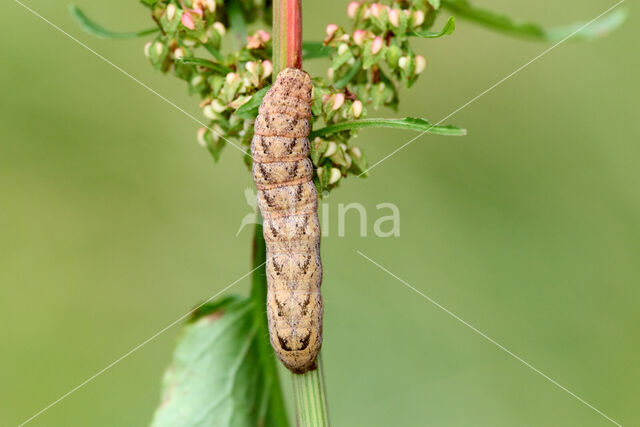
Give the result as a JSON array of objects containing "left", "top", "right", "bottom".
[{"left": 442, "top": 0, "right": 627, "bottom": 42}]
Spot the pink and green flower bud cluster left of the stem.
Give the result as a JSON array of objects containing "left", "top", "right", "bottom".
[{"left": 144, "top": 0, "right": 273, "bottom": 160}]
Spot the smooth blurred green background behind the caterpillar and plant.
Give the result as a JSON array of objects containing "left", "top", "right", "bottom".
[{"left": 0, "top": 0, "right": 640, "bottom": 426}]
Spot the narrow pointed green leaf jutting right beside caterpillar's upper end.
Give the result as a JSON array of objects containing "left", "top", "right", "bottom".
[{"left": 309, "top": 117, "right": 467, "bottom": 139}]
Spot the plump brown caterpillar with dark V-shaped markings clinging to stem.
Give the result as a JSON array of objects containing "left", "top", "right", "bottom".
[{"left": 251, "top": 68, "right": 323, "bottom": 373}]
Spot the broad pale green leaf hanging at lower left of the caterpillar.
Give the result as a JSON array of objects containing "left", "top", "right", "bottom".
[{"left": 151, "top": 297, "right": 288, "bottom": 427}]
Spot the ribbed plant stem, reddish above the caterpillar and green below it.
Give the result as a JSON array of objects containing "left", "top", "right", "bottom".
[{"left": 273, "top": 0, "right": 329, "bottom": 427}]
